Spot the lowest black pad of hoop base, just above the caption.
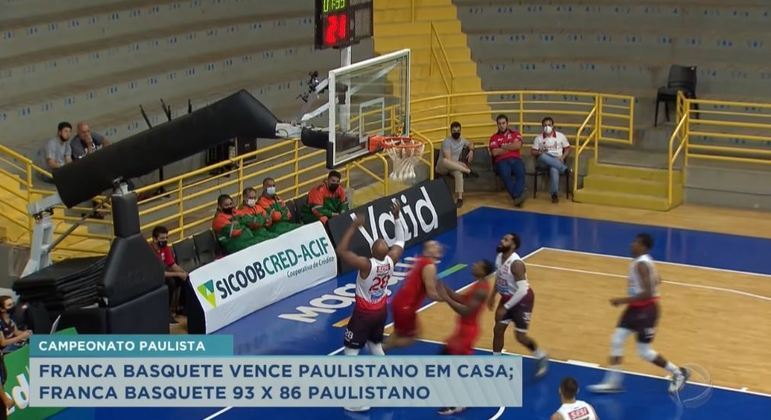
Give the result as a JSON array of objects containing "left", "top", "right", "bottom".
[{"left": 107, "top": 285, "right": 169, "bottom": 334}]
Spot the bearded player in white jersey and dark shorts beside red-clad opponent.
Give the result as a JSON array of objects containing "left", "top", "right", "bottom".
[{"left": 487, "top": 233, "right": 549, "bottom": 378}]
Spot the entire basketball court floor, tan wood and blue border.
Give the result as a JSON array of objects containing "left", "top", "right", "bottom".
[{"left": 55, "top": 207, "right": 771, "bottom": 420}]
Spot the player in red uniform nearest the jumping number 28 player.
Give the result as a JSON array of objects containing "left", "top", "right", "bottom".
[{"left": 383, "top": 241, "right": 442, "bottom": 350}]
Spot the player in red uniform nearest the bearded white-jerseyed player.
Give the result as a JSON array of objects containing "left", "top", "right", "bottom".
[{"left": 437, "top": 260, "right": 495, "bottom": 416}]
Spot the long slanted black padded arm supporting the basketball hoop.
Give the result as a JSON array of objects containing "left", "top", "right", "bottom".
[{"left": 53, "top": 90, "right": 278, "bottom": 207}]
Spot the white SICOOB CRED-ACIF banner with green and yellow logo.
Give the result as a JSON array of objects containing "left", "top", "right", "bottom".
[{"left": 190, "top": 222, "right": 337, "bottom": 333}]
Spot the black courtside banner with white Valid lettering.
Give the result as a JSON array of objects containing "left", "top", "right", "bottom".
[{"left": 327, "top": 179, "right": 458, "bottom": 274}]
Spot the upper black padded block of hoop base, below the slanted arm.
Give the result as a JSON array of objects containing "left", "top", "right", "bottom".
[{"left": 99, "top": 234, "right": 168, "bottom": 306}]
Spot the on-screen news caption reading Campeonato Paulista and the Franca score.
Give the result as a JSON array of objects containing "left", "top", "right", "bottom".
[{"left": 30, "top": 335, "right": 522, "bottom": 407}]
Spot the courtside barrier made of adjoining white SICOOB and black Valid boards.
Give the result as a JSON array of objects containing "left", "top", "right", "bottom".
[{"left": 188, "top": 179, "right": 457, "bottom": 334}]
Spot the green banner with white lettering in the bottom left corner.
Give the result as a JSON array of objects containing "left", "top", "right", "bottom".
[{"left": 0, "top": 328, "right": 77, "bottom": 420}]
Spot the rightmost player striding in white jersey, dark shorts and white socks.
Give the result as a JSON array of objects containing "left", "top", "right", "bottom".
[{"left": 589, "top": 233, "right": 690, "bottom": 393}]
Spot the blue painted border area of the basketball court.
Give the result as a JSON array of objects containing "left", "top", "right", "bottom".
[{"left": 55, "top": 208, "right": 771, "bottom": 420}]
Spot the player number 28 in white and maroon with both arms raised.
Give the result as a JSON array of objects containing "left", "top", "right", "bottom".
[{"left": 337, "top": 203, "right": 405, "bottom": 356}]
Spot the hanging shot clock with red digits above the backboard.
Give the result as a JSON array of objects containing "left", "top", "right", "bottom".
[{"left": 316, "top": 0, "right": 372, "bottom": 49}]
